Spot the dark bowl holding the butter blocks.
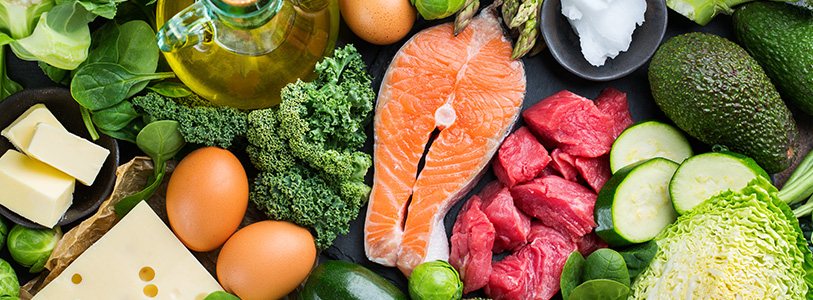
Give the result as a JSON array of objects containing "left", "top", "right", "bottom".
[{"left": 0, "top": 88, "right": 119, "bottom": 228}]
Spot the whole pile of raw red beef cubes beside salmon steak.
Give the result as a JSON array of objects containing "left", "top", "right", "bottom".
[{"left": 449, "top": 88, "right": 633, "bottom": 300}]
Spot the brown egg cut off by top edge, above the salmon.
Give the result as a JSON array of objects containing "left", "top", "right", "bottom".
[{"left": 339, "top": 0, "right": 417, "bottom": 45}]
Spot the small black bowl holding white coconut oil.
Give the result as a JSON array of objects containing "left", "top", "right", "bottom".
[{"left": 539, "top": 0, "right": 668, "bottom": 81}]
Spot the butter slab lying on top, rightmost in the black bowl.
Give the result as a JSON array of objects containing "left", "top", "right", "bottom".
[{"left": 28, "top": 123, "right": 110, "bottom": 185}]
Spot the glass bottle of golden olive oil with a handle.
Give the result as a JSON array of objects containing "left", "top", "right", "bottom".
[{"left": 156, "top": 0, "right": 339, "bottom": 109}]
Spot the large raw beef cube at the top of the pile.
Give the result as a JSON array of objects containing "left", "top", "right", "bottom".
[{"left": 522, "top": 90, "right": 614, "bottom": 157}]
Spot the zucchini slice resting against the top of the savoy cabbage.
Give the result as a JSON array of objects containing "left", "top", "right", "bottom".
[{"left": 669, "top": 151, "right": 771, "bottom": 215}]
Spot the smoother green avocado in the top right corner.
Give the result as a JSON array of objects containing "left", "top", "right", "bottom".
[{"left": 732, "top": 1, "right": 813, "bottom": 115}]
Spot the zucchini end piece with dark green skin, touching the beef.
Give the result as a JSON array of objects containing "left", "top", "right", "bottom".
[{"left": 595, "top": 157, "right": 678, "bottom": 247}]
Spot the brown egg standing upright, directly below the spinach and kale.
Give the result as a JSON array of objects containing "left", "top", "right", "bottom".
[{"left": 167, "top": 147, "right": 248, "bottom": 252}]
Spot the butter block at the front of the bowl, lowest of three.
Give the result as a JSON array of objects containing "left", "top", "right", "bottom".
[{"left": 0, "top": 149, "right": 76, "bottom": 228}]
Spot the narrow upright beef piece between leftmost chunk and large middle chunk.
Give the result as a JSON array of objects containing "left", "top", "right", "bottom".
[{"left": 480, "top": 181, "right": 531, "bottom": 253}]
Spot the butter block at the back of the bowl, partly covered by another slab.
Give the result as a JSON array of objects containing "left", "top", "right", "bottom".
[{"left": 0, "top": 103, "right": 65, "bottom": 154}]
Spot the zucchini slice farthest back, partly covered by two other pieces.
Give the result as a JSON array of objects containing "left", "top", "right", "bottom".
[{"left": 610, "top": 121, "right": 692, "bottom": 174}]
